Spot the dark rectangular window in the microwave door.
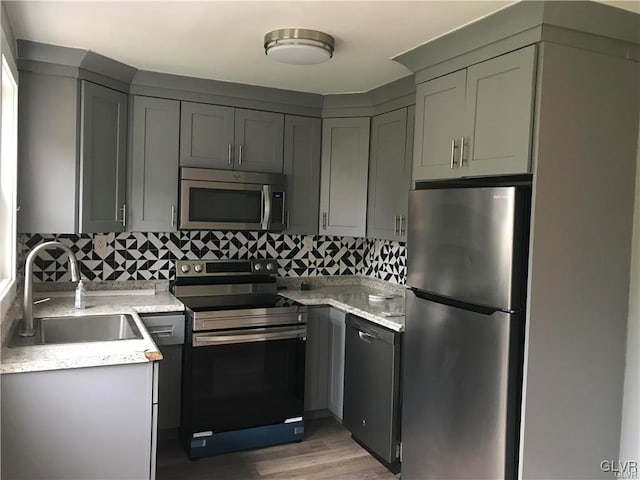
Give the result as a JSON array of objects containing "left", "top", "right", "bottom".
[{"left": 189, "top": 187, "right": 262, "bottom": 223}]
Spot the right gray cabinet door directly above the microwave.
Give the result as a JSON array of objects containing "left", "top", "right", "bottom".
[{"left": 235, "top": 108, "right": 284, "bottom": 173}]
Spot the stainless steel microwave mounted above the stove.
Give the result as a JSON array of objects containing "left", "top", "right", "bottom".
[{"left": 180, "top": 167, "right": 286, "bottom": 231}]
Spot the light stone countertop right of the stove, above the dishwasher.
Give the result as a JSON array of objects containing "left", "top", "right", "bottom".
[{"left": 278, "top": 284, "right": 404, "bottom": 332}]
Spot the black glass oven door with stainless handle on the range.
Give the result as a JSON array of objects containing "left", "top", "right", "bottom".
[{"left": 183, "top": 325, "right": 306, "bottom": 438}]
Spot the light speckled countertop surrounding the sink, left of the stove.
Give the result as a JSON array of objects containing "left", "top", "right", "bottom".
[{"left": 0, "top": 290, "right": 184, "bottom": 374}]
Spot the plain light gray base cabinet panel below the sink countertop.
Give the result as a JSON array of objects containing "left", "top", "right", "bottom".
[{"left": 1, "top": 363, "right": 156, "bottom": 480}]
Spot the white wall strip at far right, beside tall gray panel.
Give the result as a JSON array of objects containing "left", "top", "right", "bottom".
[{"left": 620, "top": 124, "right": 640, "bottom": 463}]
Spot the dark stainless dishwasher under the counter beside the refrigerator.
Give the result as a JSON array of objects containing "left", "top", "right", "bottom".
[{"left": 343, "top": 315, "right": 401, "bottom": 473}]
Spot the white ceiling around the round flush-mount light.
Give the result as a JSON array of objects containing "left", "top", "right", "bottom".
[{"left": 6, "top": 0, "right": 640, "bottom": 94}]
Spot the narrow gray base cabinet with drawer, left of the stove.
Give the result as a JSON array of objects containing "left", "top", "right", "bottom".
[{"left": 140, "top": 313, "right": 185, "bottom": 430}]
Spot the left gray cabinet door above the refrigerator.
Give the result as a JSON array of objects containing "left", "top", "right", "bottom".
[{"left": 413, "top": 70, "right": 466, "bottom": 181}]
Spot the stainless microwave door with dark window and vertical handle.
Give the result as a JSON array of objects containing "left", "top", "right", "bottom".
[{"left": 180, "top": 180, "right": 272, "bottom": 230}]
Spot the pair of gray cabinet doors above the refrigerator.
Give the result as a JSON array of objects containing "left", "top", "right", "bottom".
[{"left": 413, "top": 46, "right": 536, "bottom": 181}]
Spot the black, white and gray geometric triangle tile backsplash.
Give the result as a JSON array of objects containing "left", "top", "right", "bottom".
[{"left": 18, "top": 230, "right": 407, "bottom": 285}]
